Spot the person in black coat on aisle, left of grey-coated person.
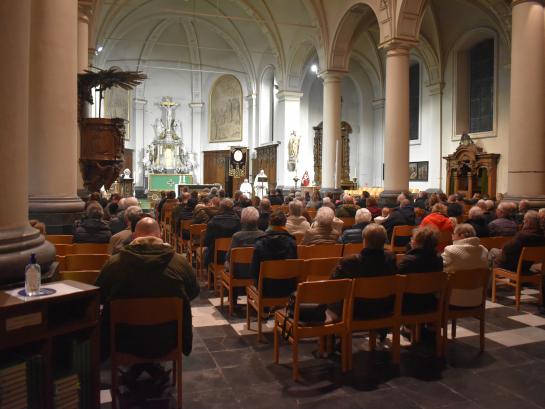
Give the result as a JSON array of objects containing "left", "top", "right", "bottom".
[{"left": 204, "top": 199, "right": 240, "bottom": 266}]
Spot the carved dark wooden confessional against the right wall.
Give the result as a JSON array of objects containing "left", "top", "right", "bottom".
[{"left": 443, "top": 134, "right": 500, "bottom": 198}]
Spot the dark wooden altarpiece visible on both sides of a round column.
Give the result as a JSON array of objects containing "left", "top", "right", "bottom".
[{"left": 312, "top": 121, "right": 354, "bottom": 189}]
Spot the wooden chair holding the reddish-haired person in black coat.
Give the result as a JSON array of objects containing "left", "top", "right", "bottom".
[{"left": 401, "top": 271, "right": 447, "bottom": 356}]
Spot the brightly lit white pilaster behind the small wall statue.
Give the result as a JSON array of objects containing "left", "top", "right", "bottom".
[{"left": 274, "top": 90, "right": 303, "bottom": 189}]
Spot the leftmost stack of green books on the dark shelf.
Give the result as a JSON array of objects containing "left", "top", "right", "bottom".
[{"left": 0, "top": 362, "right": 28, "bottom": 409}]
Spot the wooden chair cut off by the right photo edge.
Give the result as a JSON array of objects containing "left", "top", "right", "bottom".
[{"left": 492, "top": 247, "right": 545, "bottom": 311}]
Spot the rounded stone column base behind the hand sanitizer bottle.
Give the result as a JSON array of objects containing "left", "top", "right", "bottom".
[{"left": 0, "top": 225, "right": 55, "bottom": 285}]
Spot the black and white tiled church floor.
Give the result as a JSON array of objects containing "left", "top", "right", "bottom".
[{"left": 101, "top": 289, "right": 545, "bottom": 409}]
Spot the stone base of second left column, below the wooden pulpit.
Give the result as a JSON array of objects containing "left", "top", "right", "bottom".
[{"left": 28, "top": 196, "right": 85, "bottom": 234}]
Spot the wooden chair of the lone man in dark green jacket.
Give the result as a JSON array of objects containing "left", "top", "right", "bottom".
[{"left": 110, "top": 298, "right": 183, "bottom": 409}]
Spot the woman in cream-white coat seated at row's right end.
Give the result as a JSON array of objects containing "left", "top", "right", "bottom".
[{"left": 442, "top": 223, "right": 488, "bottom": 307}]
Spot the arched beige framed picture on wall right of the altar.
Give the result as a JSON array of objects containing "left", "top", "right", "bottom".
[{"left": 208, "top": 75, "right": 242, "bottom": 142}]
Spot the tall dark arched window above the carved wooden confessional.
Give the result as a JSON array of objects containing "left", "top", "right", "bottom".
[{"left": 469, "top": 39, "right": 494, "bottom": 133}]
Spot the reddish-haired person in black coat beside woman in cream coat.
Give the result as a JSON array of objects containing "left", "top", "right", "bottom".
[{"left": 397, "top": 226, "right": 443, "bottom": 314}]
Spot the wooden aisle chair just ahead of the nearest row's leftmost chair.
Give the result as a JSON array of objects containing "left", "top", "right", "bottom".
[{"left": 246, "top": 259, "right": 304, "bottom": 342}]
